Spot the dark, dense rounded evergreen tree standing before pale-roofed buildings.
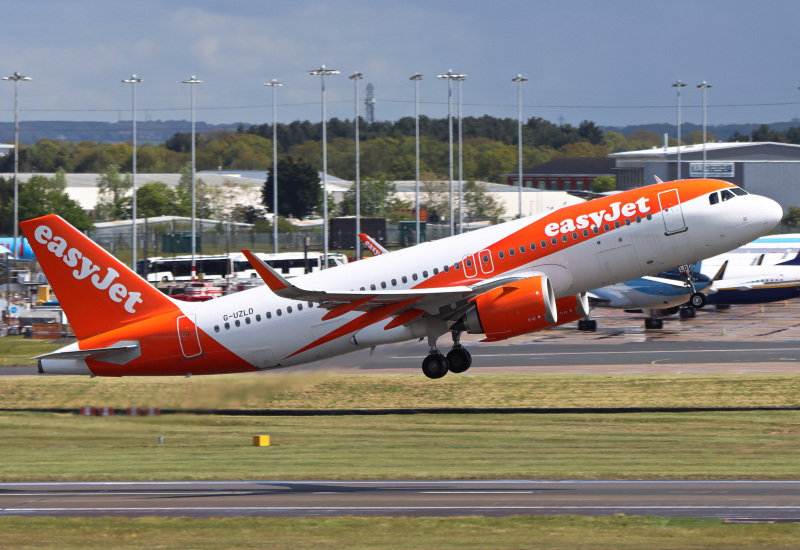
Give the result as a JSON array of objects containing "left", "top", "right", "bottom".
[{"left": 261, "top": 157, "right": 322, "bottom": 219}]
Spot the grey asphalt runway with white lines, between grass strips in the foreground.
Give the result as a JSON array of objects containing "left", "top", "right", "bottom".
[{"left": 0, "top": 480, "right": 800, "bottom": 522}]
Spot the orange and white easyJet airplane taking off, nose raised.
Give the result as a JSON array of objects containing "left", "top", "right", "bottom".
[{"left": 21, "top": 179, "right": 783, "bottom": 378}]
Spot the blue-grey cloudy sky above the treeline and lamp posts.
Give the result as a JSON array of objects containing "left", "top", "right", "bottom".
[{"left": 0, "top": 0, "right": 800, "bottom": 130}]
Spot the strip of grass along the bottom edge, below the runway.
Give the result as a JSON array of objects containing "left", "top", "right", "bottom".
[{"left": 0, "top": 516, "right": 800, "bottom": 550}]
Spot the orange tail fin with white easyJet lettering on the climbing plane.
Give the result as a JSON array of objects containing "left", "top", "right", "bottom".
[{"left": 20, "top": 215, "right": 178, "bottom": 339}]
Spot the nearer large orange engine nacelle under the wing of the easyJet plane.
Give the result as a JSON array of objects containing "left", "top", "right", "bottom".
[{"left": 453, "top": 275, "right": 558, "bottom": 342}]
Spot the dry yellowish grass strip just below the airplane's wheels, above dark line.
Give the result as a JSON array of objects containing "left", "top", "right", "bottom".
[{"left": 0, "top": 371, "right": 800, "bottom": 409}]
